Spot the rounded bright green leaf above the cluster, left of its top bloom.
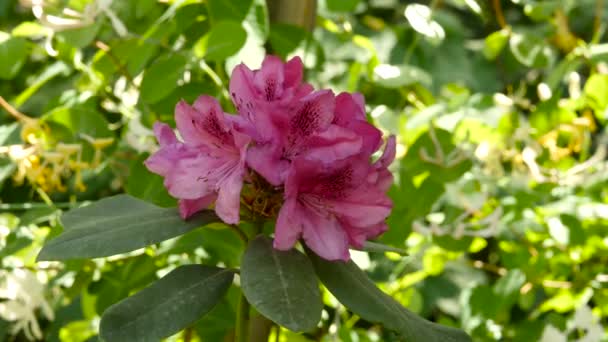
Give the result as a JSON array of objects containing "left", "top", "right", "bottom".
[{"left": 194, "top": 21, "right": 247, "bottom": 61}]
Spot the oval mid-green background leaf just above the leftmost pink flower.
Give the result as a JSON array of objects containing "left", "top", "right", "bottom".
[{"left": 139, "top": 55, "right": 187, "bottom": 104}]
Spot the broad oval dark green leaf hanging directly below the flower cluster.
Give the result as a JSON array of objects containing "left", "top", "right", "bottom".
[{"left": 241, "top": 236, "right": 323, "bottom": 331}]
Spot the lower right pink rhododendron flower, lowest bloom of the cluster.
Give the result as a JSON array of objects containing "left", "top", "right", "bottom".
[{"left": 274, "top": 138, "right": 395, "bottom": 260}]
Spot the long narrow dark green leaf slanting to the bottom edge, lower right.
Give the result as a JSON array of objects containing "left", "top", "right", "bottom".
[{"left": 308, "top": 251, "right": 471, "bottom": 342}]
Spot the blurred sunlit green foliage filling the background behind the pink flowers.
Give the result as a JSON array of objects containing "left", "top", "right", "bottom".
[{"left": 0, "top": 0, "right": 608, "bottom": 341}]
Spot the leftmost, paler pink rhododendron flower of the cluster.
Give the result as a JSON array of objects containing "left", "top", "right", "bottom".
[{"left": 145, "top": 96, "right": 250, "bottom": 223}]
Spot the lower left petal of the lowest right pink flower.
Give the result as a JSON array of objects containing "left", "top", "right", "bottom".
[{"left": 273, "top": 198, "right": 302, "bottom": 251}]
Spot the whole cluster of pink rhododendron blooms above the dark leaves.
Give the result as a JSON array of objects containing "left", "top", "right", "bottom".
[{"left": 146, "top": 56, "right": 395, "bottom": 260}]
